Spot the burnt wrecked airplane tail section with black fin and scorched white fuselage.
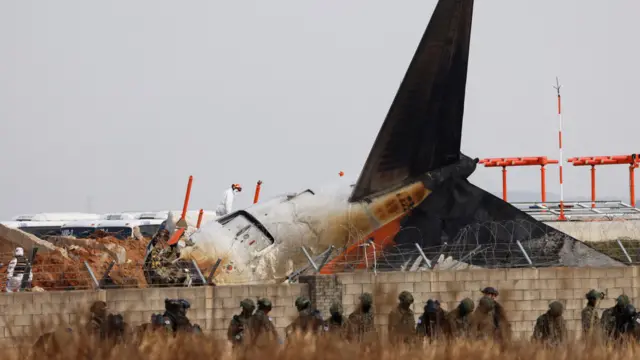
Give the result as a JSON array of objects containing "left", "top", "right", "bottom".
[{"left": 181, "top": 0, "right": 623, "bottom": 283}]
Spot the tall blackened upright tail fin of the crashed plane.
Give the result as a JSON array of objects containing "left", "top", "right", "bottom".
[{"left": 350, "top": 0, "right": 474, "bottom": 202}]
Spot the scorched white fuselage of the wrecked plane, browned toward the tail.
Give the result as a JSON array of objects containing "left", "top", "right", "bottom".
[{"left": 181, "top": 183, "right": 430, "bottom": 284}]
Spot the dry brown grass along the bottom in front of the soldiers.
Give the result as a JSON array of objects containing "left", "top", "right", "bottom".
[{"left": 7, "top": 312, "right": 640, "bottom": 360}]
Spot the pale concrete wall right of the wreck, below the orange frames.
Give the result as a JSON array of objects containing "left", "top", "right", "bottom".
[{"left": 545, "top": 220, "right": 640, "bottom": 241}]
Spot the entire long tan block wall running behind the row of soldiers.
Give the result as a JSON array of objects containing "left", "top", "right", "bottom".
[{"left": 0, "top": 267, "right": 640, "bottom": 340}]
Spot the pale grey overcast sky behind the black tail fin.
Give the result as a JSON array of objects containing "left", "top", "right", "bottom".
[{"left": 0, "top": 0, "right": 640, "bottom": 220}]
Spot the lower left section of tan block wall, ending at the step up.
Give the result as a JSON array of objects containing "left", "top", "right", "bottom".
[{"left": 0, "top": 284, "right": 309, "bottom": 343}]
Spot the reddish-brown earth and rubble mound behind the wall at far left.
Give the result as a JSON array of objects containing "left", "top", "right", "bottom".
[{"left": 0, "top": 224, "right": 148, "bottom": 291}]
